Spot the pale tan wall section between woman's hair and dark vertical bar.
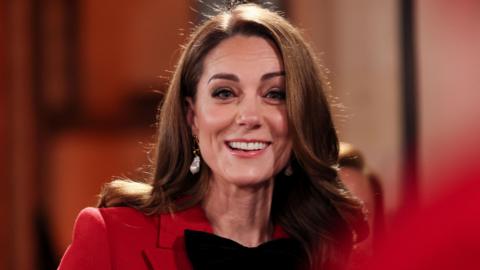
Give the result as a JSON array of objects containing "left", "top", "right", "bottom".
[{"left": 289, "top": 0, "right": 401, "bottom": 213}]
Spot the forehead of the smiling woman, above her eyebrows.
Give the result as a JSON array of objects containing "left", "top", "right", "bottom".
[{"left": 203, "top": 35, "right": 283, "bottom": 76}]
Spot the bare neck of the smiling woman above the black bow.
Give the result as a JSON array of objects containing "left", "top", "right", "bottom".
[{"left": 203, "top": 176, "right": 273, "bottom": 247}]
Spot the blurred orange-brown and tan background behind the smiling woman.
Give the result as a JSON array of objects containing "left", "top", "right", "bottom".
[{"left": 0, "top": 0, "right": 480, "bottom": 270}]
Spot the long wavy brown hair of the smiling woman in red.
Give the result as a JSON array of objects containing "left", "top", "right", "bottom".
[{"left": 98, "top": 4, "right": 368, "bottom": 269}]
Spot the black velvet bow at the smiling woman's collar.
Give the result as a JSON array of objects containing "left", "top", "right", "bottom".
[{"left": 184, "top": 230, "right": 303, "bottom": 270}]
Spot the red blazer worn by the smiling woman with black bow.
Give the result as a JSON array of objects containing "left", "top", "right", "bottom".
[{"left": 58, "top": 206, "right": 288, "bottom": 270}]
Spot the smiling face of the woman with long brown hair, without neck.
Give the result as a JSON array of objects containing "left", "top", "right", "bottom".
[{"left": 188, "top": 35, "right": 292, "bottom": 186}]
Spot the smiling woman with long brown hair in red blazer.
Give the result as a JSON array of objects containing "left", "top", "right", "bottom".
[{"left": 60, "top": 4, "right": 367, "bottom": 269}]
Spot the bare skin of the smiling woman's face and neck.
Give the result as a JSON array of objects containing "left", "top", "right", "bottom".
[{"left": 187, "top": 35, "right": 292, "bottom": 247}]
